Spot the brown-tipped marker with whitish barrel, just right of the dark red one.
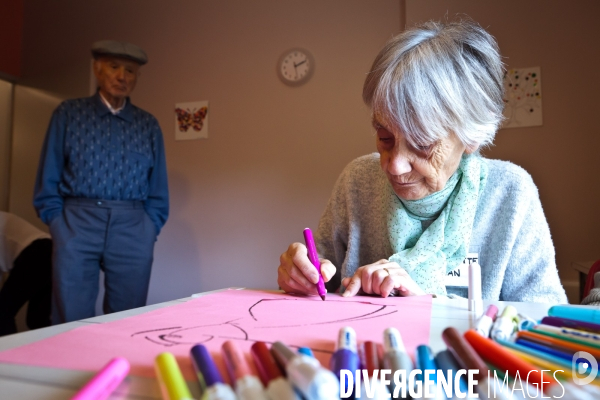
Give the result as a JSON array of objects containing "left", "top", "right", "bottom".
[{"left": 271, "top": 342, "right": 340, "bottom": 400}]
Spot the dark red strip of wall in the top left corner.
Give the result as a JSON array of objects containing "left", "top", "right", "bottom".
[{"left": 0, "top": 0, "right": 23, "bottom": 78}]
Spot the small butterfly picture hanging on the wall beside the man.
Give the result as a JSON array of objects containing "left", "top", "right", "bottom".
[{"left": 175, "top": 101, "right": 208, "bottom": 140}]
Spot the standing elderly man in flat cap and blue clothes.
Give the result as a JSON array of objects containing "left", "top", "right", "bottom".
[{"left": 33, "top": 41, "right": 169, "bottom": 323}]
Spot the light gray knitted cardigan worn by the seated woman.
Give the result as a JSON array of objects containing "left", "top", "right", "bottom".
[{"left": 316, "top": 153, "right": 567, "bottom": 303}]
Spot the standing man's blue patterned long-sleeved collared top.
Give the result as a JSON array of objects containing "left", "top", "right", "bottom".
[{"left": 34, "top": 93, "right": 169, "bottom": 232}]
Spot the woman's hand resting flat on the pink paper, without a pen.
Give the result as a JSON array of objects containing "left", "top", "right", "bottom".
[{"left": 342, "top": 260, "right": 425, "bottom": 297}]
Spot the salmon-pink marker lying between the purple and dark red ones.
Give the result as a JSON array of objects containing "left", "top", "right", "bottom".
[{"left": 221, "top": 340, "right": 268, "bottom": 400}]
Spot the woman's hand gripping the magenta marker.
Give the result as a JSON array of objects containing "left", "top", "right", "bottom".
[{"left": 277, "top": 243, "right": 335, "bottom": 296}]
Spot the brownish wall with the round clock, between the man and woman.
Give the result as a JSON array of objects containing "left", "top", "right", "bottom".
[{"left": 19, "top": 0, "right": 401, "bottom": 303}]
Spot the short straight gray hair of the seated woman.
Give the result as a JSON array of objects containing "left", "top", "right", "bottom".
[{"left": 363, "top": 20, "right": 504, "bottom": 146}]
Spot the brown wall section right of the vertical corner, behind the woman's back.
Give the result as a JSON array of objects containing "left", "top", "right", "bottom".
[{"left": 406, "top": 0, "right": 600, "bottom": 301}]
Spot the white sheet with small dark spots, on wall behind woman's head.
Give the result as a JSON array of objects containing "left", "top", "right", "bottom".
[{"left": 502, "top": 67, "right": 542, "bottom": 128}]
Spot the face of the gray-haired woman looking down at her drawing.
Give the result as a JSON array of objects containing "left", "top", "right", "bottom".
[{"left": 373, "top": 119, "right": 476, "bottom": 200}]
